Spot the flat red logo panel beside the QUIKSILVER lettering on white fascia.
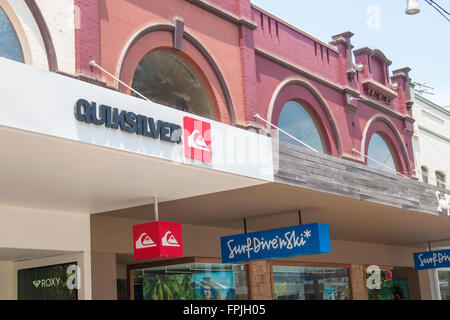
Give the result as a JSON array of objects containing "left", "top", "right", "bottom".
[{"left": 183, "top": 117, "right": 212, "bottom": 162}]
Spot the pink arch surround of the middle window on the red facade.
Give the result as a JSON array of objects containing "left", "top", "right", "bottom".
[{"left": 267, "top": 77, "right": 342, "bottom": 157}]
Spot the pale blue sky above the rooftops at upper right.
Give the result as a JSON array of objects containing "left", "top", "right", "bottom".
[{"left": 251, "top": 0, "right": 450, "bottom": 106}]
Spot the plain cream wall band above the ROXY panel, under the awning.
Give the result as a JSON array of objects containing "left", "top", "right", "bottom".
[{"left": 0, "top": 206, "right": 90, "bottom": 251}]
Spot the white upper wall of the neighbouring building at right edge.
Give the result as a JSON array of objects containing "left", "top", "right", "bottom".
[{"left": 413, "top": 97, "right": 450, "bottom": 189}]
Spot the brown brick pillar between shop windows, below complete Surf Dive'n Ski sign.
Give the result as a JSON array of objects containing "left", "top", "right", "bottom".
[{"left": 248, "top": 261, "right": 273, "bottom": 300}]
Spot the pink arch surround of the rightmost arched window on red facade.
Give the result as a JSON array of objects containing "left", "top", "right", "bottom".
[{"left": 361, "top": 114, "right": 412, "bottom": 176}]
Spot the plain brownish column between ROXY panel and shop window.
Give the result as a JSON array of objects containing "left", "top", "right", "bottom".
[{"left": 91, "top": 252, "right": 117, "bottom": 300}]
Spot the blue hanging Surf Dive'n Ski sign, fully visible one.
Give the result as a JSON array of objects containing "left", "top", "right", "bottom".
[{"left": 221, "top": 223, "right": 331, "bottom": 263}]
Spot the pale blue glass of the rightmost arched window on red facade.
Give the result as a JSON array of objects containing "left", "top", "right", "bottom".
[{"left": 367, "top": 133, "right": 398, "bottom": 172}]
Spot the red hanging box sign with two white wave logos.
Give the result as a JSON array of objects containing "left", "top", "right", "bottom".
[{"left": 133, "top": 221, "right": 183, "bottom": 260}]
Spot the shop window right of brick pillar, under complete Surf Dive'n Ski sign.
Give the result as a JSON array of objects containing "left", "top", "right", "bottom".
[{"left": 273, "top": 266, "right": 351, "bottom": 300}]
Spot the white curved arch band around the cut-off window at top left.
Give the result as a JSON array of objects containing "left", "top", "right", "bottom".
[{"left": 1, "top": 0, "right": 49, "bottom": 70}]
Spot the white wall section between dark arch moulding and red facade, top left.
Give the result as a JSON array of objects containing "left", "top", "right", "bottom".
[{"left": 35, "top": 0, "right": 75, "bottom": 74}]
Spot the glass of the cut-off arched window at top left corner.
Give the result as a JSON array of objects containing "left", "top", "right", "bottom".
[{"left": 0, "top": 6, "right": 25, "bottom": 62}]
